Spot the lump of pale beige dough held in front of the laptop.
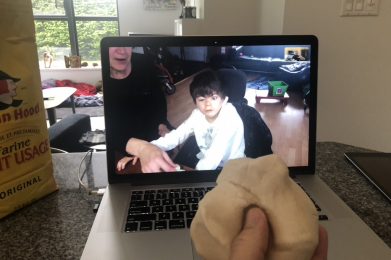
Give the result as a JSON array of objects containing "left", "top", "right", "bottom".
[{"left": 190, "top": 155, "right": 319, "bottom": 260}]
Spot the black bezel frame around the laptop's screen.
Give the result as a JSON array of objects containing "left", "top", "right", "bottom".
[{"left": 101, "top": 35, "right": 318, "bottom": 185}]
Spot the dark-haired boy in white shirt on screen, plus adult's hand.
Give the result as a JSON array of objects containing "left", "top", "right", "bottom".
[{"left": 126, "top": 70, "right": 245, "bottom": 172}]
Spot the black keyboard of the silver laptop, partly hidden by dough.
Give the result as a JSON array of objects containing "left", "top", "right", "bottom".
[{"left": 125, "top": 183, "right": 328, "bottom": 232}]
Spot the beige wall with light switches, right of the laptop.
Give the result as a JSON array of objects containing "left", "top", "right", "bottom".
[{"left": 283, "top": 0, "right": 391, "bottom": 152}]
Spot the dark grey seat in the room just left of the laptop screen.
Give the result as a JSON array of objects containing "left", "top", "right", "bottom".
[{"left": 48, "top": 114, "right": 91, "bottom": 153}]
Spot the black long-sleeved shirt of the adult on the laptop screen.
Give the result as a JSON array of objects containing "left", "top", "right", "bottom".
[{"left": 103, "top": 53, "right": 168, "bottom": 155}]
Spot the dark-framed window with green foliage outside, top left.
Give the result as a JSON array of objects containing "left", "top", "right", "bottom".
[{"left": 31, "top": 0, "right": 119, "bottom": 68}]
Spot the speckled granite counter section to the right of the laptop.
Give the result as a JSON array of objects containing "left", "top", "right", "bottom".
[{"left": 316, "top": 142, "right": 391, "bottom": 247}]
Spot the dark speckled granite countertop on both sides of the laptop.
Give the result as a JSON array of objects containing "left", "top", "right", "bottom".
[{"left": 0, "top": 142, "right": 391, "bottom": 260}]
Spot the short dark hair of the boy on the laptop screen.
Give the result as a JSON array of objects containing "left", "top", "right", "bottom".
[{"left": 190, "top": 70, "right": 226, "bottom": 103}]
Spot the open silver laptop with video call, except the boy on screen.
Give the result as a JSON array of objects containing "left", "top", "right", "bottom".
[{"left": 82, "top": 35, "right": 391, "bottom": 259}]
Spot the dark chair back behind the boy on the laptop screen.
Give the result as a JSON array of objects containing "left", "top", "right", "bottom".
[{"left": 217, "top": 69, "right": 273, "bottom": 158}]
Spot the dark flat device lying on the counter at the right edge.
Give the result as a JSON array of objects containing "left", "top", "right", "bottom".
[{"left": 345, "top": 152, "right": 391, "bottom": 201}]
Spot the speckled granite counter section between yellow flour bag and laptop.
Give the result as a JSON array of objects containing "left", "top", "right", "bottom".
[{"left": 0, "top": 153, "right": 100, "bottom": 260}]
